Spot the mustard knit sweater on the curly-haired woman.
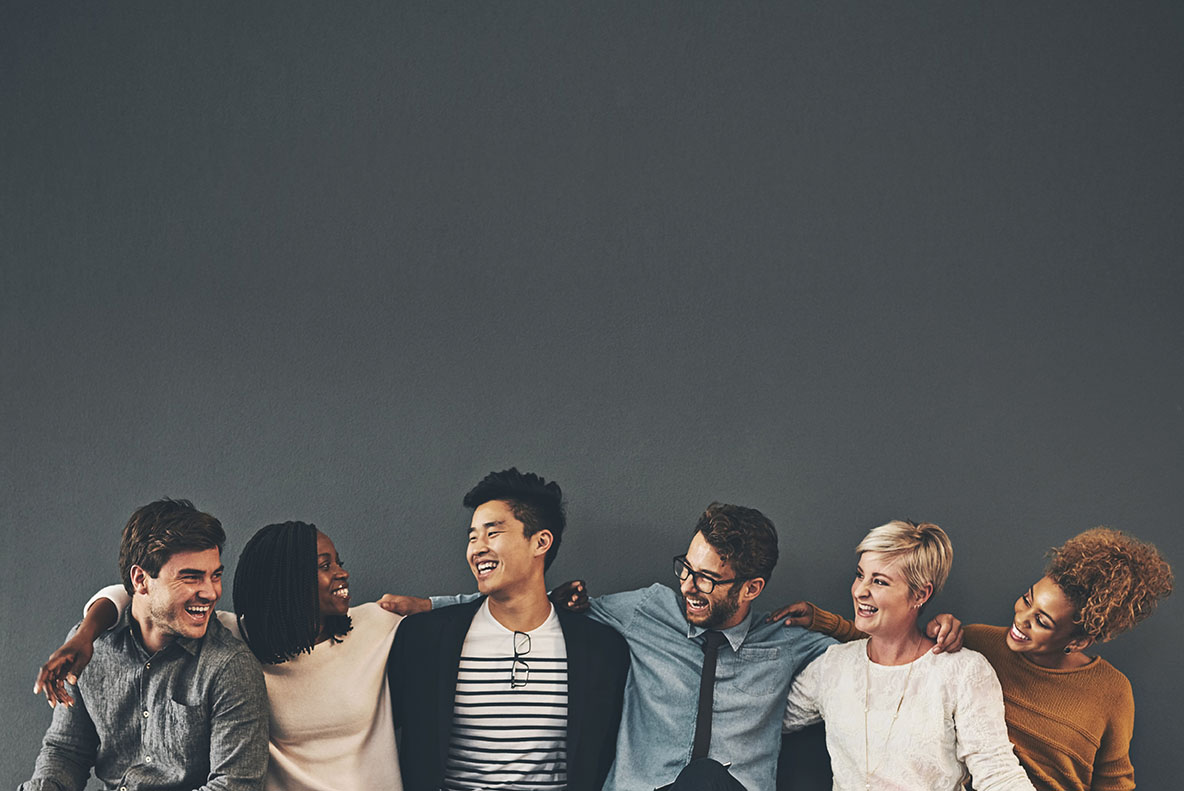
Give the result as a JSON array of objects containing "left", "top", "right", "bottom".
[{"left": 811, "top": 607, "right": 1134, "bottom": 791}]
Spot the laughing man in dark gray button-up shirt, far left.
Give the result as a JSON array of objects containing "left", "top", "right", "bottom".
[{"left": 20, "top": 500, "right": 268, "bottom": 791}]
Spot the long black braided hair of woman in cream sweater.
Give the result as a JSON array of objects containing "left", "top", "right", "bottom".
[{"left": 234, "top": 522, "right": 353, "bottom": 664}]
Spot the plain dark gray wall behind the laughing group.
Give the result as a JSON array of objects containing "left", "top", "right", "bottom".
[{"left": 0, "top": 1, "right": 1184, "bottom": 789}]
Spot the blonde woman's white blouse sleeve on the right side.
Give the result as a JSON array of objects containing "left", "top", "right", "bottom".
[{"left": 953, "top": 650, "right": 1034, "bottom": 791}]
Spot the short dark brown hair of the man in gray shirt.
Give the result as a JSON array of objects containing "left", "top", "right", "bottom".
[{"left": 120, "top": 497, "right": 226, "bottom": 594}]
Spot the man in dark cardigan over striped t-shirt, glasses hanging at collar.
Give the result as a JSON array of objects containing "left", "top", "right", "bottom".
[{"left": 388, "top": 469, "right": 629, "bottom": 791}]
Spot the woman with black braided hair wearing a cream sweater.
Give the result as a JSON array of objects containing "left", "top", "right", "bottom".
[{"left": 38, "top": 522, "right": 403, "bottom": 791}]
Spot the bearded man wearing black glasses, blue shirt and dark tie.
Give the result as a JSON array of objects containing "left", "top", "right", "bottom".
[{"left": 391, "top": 503, "right": 835, "bottom": 791}]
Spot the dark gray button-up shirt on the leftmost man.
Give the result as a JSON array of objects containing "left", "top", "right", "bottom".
[{"left": 20, "top": 607, "right": 269, "bottom": 791}]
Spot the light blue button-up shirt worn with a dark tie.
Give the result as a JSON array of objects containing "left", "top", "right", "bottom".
[{"left": 432, "top": 584, "right": 835, "bottom": 791}]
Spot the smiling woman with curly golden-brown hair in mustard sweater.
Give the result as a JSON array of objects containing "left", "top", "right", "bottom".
[{"left": 774, "top": 527, "right": 1172, "bottom": 791}]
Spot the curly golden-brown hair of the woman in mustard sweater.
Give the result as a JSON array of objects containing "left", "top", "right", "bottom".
[{"left": 1045, "top": 527, "right": 1172, "bottom": 642}]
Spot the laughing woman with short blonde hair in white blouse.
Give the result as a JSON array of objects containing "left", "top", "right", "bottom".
[{"left": 783, "top": 521, "right": 1032, "bottom": 791}]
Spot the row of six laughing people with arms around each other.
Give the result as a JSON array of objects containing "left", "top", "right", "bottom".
[{"left": 21, "top": 469, "right": 1172, "bottom": 791}]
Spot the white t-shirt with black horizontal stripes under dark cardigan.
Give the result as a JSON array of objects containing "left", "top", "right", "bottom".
[{"left": 443, "top": 599, "right": 567, "bottom": 791}]
